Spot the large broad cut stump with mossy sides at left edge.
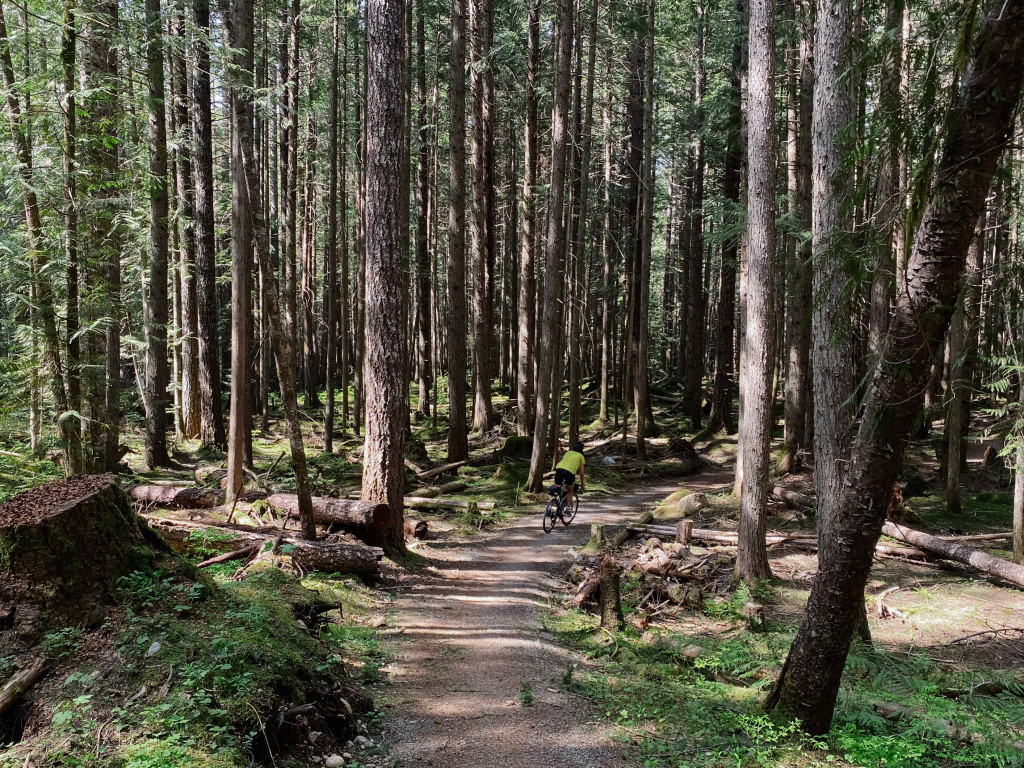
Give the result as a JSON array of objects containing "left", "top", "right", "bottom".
[{"left": 0, "top": 475, "right": 161, "bottom": 640}]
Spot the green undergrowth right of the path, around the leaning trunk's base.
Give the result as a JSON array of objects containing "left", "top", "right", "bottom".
[{"left": 546, "top": 585, "right": 1024, "bottom": 768}]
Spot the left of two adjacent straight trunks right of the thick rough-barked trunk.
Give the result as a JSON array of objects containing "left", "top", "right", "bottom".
[{"left": 447, "top": 0, "right": 469, "bottom": 462}]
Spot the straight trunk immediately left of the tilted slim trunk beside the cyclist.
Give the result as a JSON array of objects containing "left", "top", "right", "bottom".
[{"left": 516, "top": 0, "right": 541, "bottom": 436}]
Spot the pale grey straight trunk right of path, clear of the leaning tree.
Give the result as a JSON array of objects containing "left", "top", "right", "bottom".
[{"left": 736, "top": 0, "right": 776, "bottom": 587}]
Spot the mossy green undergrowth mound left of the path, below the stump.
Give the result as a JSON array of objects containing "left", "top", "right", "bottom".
[{"left": 0, "top": 558, "right": 386, "bottom": 768}]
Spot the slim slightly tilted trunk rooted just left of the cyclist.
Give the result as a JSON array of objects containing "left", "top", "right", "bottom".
[{"left": 526, "top": 0, "right": 573, "bottom": 492}]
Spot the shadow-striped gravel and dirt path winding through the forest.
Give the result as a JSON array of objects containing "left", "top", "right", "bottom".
[{"left": 389, "top": 475, "right": 708, "bottom": 768}]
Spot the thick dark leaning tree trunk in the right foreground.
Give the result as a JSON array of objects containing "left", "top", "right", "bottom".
[{"left": 766, "top": 0, "right": 1024, "bottom": 733}]
